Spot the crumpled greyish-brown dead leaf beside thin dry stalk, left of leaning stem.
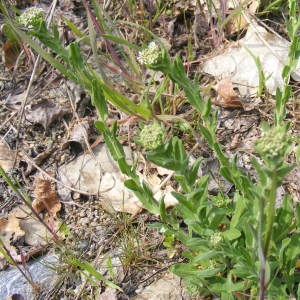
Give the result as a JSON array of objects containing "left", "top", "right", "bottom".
[{"left": 25, "top": 100, "right": 70, "bottom": 130}]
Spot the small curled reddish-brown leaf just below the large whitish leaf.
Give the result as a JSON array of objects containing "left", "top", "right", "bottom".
[{"left": 215, "top": 78, "right": 243, "bottom": 108}]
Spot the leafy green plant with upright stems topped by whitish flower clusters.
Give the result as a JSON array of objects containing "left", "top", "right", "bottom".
[{"left": 1, "top": 0, "right": 300, "bottom": 300}]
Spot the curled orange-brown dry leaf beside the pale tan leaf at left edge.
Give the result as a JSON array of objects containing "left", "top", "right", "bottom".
[{"left": 32, "top": 178, "right": 61, "bottom": 217}]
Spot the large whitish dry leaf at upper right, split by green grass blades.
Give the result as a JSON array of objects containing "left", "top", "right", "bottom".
[{"left": 203, "top": 24, "right": 300, "bottom": 96}]
